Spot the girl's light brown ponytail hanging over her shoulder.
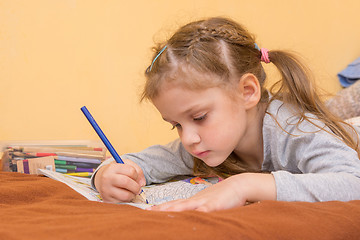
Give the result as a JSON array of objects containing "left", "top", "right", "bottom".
[{"left": 269, "top": 51, "right": 360, "bottom": 157}]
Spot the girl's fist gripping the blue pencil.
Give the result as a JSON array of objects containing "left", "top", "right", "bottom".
[{"left": 94, "top": 160, "right": 146, "bottom": 203}]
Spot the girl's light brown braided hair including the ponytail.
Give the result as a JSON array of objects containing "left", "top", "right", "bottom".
[{"left": 141, "top": 18, "right": 360, "bottom": 177}]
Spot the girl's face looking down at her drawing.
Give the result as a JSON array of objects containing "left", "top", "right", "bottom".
[{"left": 153, "top": 83, "right": 252, "bottom": 167}]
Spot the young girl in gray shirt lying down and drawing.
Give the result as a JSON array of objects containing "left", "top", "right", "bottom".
[{"left": 93, "top": 18, "right": 360, "bottom": 211}]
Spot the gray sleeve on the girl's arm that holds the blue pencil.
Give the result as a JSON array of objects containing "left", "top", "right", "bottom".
[{"left": 91, "top": 139, "right": 194, "bottom": 189}]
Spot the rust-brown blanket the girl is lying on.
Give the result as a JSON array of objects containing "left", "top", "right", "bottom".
[{"left": 0, "top": 172, "right": 360, "bottom": 240}]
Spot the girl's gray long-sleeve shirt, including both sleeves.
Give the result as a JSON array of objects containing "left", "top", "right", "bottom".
[{"left": 92, "top": 100, "right": 360, "bottom": 202}]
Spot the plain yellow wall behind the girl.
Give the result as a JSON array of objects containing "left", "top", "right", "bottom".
[{"left": 0, "top": 0, "right": 360, "bottom": 153}]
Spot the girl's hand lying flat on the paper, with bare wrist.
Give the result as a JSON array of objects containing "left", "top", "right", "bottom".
[{"left": 148, "top": 173, "right": 276, "bottom": 212}]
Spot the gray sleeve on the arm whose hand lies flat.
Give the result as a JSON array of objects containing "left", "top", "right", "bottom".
[{"left": 272, "top": 126, "right": 360, "bottom": 202}]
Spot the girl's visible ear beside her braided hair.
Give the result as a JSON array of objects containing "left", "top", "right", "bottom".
[{"left": 238, "top": 73, "right": 261, "bottom": 110}]
